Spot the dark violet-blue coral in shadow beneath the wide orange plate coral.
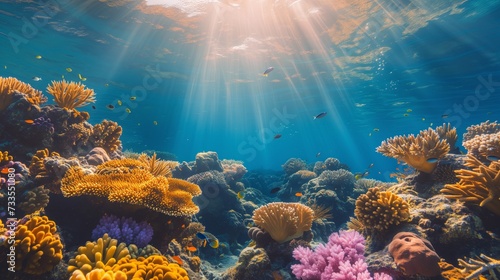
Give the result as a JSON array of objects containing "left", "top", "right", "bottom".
[{"left": 92, "top": 215, "right": 153, "bottom": 248}]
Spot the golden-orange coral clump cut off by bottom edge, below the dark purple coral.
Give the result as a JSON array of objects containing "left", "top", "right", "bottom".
[{"left": 113, "top": 255, "right": 189, "bottom": 280}]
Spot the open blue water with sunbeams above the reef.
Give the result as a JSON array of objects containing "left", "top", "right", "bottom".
[{"left": 0, "top": 0, "right": 500, "bottom": 181}]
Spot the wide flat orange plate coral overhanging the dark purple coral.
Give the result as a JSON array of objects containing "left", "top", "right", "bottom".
[{"left": 61, "top": 159, "right": 201, "bottom": 216}]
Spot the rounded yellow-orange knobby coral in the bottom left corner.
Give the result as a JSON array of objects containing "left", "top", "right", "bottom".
[{"left": 14, "top": 216, "right": 63, "bottom": 275}]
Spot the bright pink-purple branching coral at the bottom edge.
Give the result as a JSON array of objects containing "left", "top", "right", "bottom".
[{"left": 292, "top": 231, "right": 392, "bottom": 280}]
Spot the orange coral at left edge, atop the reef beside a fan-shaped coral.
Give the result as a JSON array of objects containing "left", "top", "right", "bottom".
[{"left": 0, "top": 77, "right": 47, "bottom": 111}]
